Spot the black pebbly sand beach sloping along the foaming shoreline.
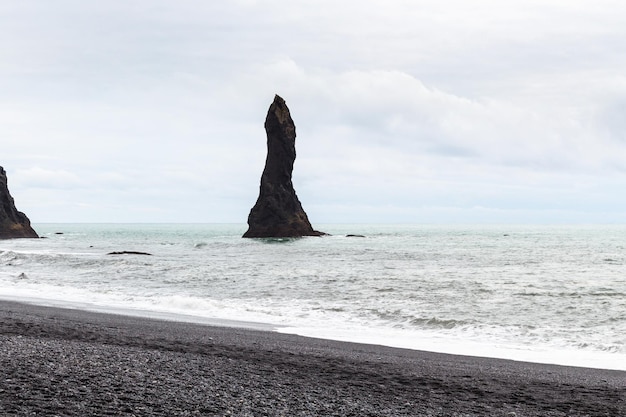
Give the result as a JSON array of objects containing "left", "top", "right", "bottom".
[{"left": 0, "top": 301, "right": 626, "bottom": 417}]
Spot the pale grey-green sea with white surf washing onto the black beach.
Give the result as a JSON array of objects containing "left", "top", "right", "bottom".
[{"left": 0, "top": 224, "right": 626, "bottom": 369}]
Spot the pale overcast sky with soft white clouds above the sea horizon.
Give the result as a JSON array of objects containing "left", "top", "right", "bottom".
[{"left": 0, "top": 0, "right": 626, "bottom": 226}]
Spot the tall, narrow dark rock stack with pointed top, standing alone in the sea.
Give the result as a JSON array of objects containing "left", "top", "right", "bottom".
[{"left": 243, "top": 96, "right": 324, "bottom": 237}]
